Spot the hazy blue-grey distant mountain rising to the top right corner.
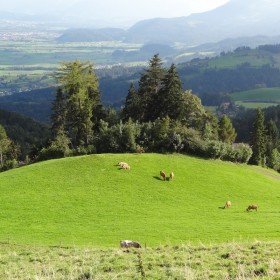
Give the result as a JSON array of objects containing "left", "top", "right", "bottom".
[{"left": 126, "top": 0, "right": 280, "bottom": 45}]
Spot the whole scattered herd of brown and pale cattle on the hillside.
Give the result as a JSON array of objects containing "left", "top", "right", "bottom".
[{"left": 117, "top": 162, "right": 258, "bottom": 248}]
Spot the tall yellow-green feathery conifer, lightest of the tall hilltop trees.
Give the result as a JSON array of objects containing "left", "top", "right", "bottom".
[{"left": 56, "top": 60, "right": 101, "bottom": 148}]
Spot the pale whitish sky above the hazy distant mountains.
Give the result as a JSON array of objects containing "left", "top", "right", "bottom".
[{"left": 0, "top": 0, "right": 229, "bottom": 26}]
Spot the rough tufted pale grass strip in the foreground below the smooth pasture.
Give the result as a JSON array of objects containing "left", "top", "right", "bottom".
[{"left": 0, "top": 241, "right": 280, "bottom": 280}]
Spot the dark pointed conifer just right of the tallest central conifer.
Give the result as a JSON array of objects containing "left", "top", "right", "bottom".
[{"left": 155, "top": 64, "right": 182, "bottom": 120}]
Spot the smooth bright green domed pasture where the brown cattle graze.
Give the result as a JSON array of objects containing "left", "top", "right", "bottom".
[{"left": 0, "top": 154, "right": 280, "bottom": 247}]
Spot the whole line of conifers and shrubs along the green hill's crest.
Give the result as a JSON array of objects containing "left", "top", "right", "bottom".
[{"left": 2, "top": 54, "right": 280, "bottom": 170}]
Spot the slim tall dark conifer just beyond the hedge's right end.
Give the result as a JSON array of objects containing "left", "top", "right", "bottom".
[{"left": 251, "top": 108, "right": 266, "bottom": 165}]
